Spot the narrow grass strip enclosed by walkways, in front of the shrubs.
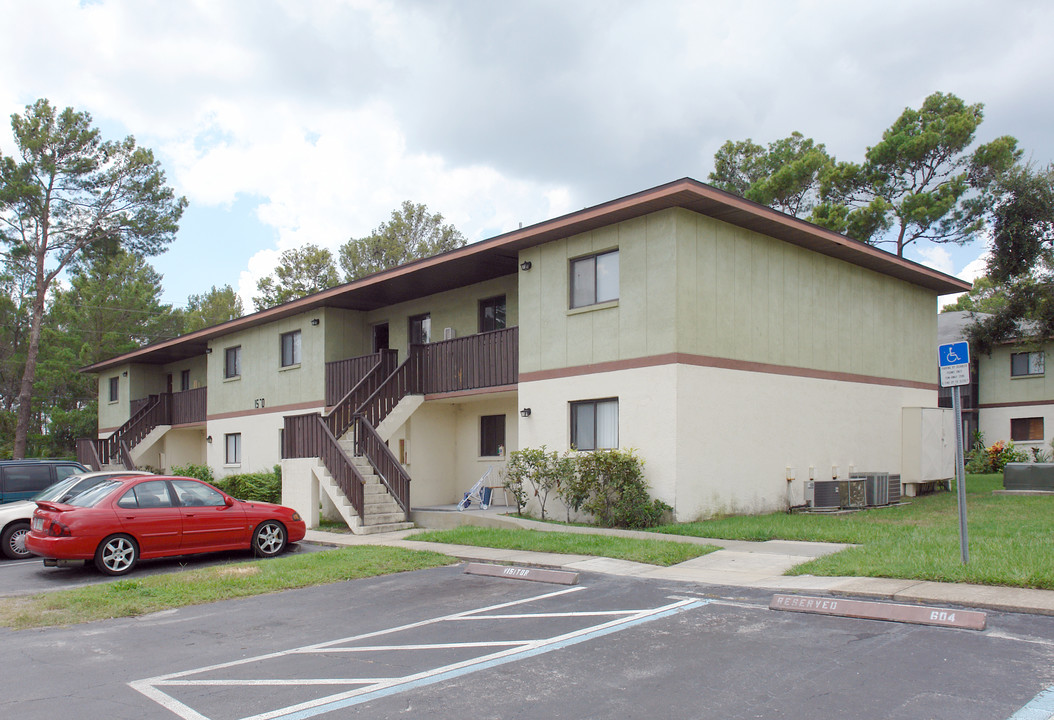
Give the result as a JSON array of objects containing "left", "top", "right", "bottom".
[{"left": 412, "top": 525, "right": 721, "bottom": 566}]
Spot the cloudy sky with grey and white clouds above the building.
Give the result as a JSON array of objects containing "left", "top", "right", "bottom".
[{"left": 0, "top": 0, "right": 1054, "bottom": 311}]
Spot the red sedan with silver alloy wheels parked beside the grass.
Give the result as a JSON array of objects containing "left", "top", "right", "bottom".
[{"left": 25, "top": 475, "right": 306, "bottom": 575}]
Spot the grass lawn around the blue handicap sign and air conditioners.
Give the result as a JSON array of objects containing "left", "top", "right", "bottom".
[{"left": 652, "top": 474, "right": 1054, "bottom": 589}]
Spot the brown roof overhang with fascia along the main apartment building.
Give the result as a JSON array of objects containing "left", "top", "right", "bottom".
[{"left": 80, "top": 177, "right": 971, "bottom": 372}]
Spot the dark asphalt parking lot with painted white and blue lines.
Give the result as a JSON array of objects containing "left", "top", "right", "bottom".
[{"left": 0, "top": 566, "right": 1054, "bottom": 720}]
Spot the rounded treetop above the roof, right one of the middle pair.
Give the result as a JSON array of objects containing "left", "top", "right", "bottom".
[{"left": 339, "top": 200, "right": 465, "bottom": 283}]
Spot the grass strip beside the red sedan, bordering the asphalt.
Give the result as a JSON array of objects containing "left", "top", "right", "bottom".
[{"left": 0, "top": 545, "right": 457, "bottom": 629}]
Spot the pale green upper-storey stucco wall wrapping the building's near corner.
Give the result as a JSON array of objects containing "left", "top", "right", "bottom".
[{"left": 520, "top": 209, "right": 937, "bottom": 384}]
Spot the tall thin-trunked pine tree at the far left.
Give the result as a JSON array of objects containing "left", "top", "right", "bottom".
[{"left": 0, "top": 99, "right": 187, "bottom": 458}]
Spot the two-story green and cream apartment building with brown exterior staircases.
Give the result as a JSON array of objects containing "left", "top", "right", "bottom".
[{"left": 82, "top": 179, "right": 969, "bottom": 531}]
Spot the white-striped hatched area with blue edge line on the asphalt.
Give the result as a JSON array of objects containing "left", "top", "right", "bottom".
[{"left": 131, "top": 587, "right": 708, "bottom": 720}]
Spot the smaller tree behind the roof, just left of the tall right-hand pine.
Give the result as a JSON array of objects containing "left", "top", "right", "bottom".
[{"left": 709, "top": 132, "right": 834, "bottom": 217}]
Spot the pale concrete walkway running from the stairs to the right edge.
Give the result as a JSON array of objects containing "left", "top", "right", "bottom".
[{"left": 305, "top": 507, "right": 1054, "bottom": 616}]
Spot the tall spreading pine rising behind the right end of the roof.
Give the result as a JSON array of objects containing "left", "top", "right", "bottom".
[{"left": 812, "top": 93, "right": 1020, "bottom": 256}]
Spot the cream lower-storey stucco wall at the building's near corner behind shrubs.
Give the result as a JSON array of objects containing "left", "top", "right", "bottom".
[{"left": 520, "top": 365, "right": 937, "bottom": 521}]
